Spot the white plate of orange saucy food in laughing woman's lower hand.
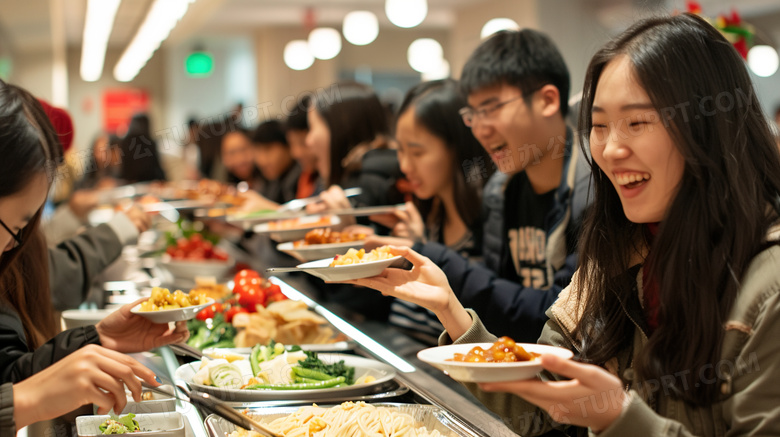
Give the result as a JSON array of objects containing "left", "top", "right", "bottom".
[{"left": 417, "top": 337, "right": 574, "bottom": 382}]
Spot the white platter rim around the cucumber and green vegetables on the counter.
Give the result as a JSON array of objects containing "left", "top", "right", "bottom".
[{"left": 175, "top": 354, "right": 396, "bottom": 402}]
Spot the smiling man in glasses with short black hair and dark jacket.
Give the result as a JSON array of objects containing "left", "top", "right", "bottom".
[{"left": 414, "top": 29, "right": 590, "bottom": 343}]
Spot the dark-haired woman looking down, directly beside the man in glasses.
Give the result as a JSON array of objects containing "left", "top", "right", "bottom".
[{"left": 378, "top": 79, "right": 490, "bottom": 344}]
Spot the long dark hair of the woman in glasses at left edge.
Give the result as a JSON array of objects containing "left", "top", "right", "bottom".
[{"left": 0, "top": 80, "right": 62, "bottom": 348}]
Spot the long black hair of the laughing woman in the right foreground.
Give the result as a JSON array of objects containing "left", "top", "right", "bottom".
[{"left": 575, "top": 14, "right": 780, "bottom": 405}]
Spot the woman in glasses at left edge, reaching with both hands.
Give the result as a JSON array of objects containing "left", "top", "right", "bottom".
[{"left": 0, "top": 81, "right": 183, "bottom": 435}]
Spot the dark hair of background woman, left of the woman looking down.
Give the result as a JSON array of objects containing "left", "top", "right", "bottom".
[{"left": 313, "top": 82, "right": 390, "bottom": 185}]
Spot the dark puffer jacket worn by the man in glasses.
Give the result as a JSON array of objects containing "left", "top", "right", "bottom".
[{"left": 413, "top": 131, "right": 590, "bottom": 343}]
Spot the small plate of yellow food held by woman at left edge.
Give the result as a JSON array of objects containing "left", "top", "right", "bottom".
[{"left": 130, "top": 287, "right": 214, "bottom": 323}]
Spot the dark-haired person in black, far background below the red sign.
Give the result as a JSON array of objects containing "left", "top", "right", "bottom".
[{"left": 119, "top": 114, "right": 165, "bottom": 183}]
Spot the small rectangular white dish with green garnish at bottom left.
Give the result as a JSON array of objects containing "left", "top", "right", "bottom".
[{"left": 76, "top": 411, "right": 185, "bottom": 437}]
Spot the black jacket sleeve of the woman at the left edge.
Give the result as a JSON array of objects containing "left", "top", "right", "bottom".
[{"left": 0, "top": 304, "right": 100, "bottom": 384}]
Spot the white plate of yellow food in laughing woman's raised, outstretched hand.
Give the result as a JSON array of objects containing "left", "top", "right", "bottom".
[{"left": 266, "top": 246, "right": 403, "bottom": 282}]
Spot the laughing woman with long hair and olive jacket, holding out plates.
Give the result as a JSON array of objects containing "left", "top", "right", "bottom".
[{"left": 344, "top": 14, "right": 780, "bottom": 436}]
